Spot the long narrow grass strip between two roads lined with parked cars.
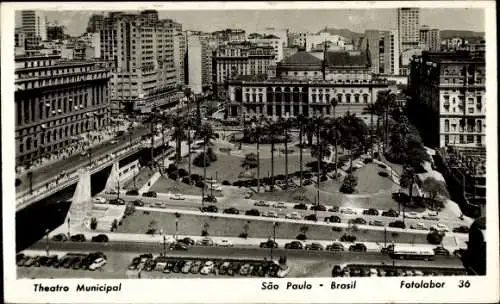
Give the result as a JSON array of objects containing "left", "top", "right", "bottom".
[{"left": 118, "top": 211, "right": 427, "bottom": 243}]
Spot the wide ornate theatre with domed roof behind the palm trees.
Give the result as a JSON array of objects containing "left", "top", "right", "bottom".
[{"left": 227, "top": 51, "right": 388, "bottom": 122}]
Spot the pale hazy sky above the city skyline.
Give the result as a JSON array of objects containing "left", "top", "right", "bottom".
[{"left": 16, "top": 8, "right": 485, "bottom": 36}]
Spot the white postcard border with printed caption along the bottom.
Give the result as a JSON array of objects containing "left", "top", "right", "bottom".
[{"left": 1, "top": 1, "right": 499, "bottom": 303}]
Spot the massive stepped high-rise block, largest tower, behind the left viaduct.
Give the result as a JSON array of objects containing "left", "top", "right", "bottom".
[{"left": 100, "top": 10, "right": 178, "bottom": 113}]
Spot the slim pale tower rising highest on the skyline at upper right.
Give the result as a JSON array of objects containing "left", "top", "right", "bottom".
[{"left": 398, "top": 7, "right": 420, "bottom": 52}]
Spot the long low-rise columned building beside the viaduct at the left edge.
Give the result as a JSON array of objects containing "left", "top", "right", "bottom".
[{"left": 14, "top": 54, "right": 110, "bottom": 164}]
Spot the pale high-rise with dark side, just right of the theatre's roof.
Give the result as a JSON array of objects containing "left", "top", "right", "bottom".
[{"left": 361, "top": 30, "right": 399, "bottom": 75}]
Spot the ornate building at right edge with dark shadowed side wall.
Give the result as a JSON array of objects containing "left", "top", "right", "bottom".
[{"left": 409, "top": 51, "right": 486, "bottom": 149}]
